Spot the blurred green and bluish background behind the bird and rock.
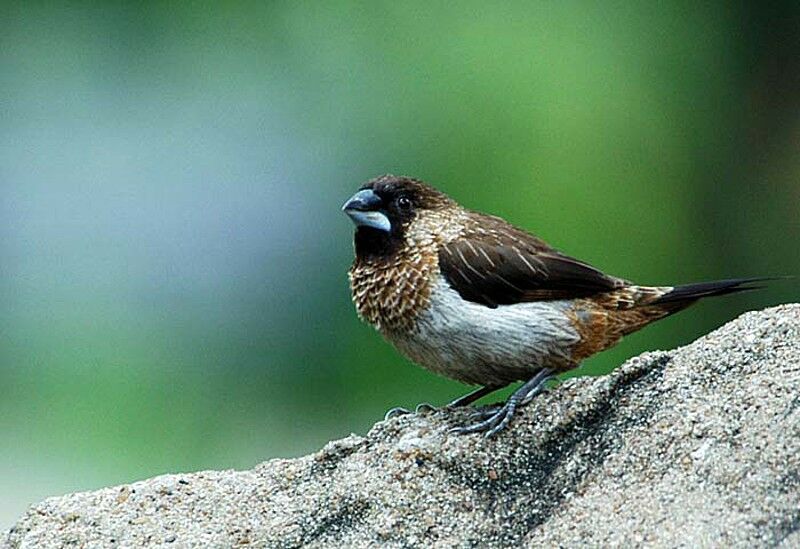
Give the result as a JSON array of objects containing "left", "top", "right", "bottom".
[{"left": 0, "top": 1, "right": 800, "bottom": 527}]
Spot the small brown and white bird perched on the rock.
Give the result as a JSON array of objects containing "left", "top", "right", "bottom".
[{"left": 342, "top": 174, "right": 765, "bottom": 437}]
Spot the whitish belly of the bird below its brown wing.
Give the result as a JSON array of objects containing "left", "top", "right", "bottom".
[{"left": 386, "top": 279, "right": 579, "bottom": 385}]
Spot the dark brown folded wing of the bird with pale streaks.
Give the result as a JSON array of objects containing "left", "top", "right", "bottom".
[{"left": 439, "top": 214, "right": 627, "bottom": 308}]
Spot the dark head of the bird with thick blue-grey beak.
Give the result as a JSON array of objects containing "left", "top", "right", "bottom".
[{"left": 342, "top": 175, "right": 455, "bottom": 257}]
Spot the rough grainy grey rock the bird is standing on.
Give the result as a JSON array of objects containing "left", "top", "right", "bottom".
[{"left": 0, "top": 305, "right": 800, "bottom": 547}]
